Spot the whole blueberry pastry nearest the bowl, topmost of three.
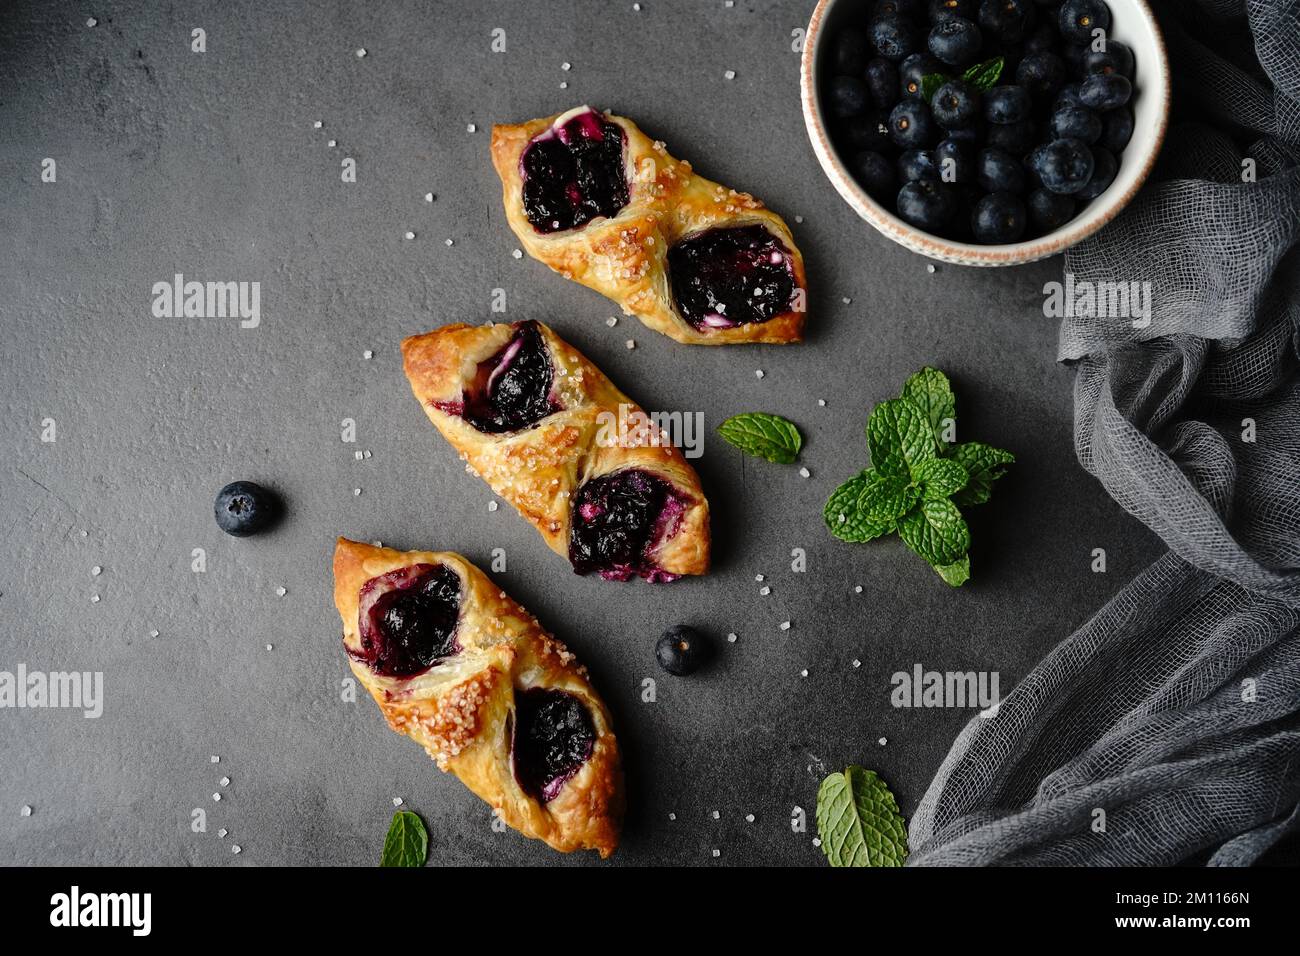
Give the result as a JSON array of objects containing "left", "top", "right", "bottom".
[{"left": 491, "top": 107, "right": 806, "bottom": 345}]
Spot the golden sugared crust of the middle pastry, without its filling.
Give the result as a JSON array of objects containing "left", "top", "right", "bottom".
[{"left": 402, "top": 323, "right": 710, "bottom": 575}]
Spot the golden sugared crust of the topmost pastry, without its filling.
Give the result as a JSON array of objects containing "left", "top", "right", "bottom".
[{"left": 491, "top": 111, "right": 807, "bottom": 345}]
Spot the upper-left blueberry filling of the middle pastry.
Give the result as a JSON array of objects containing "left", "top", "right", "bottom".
[{"left": 437, "top": 321, "right": 560, "bottom": 434}]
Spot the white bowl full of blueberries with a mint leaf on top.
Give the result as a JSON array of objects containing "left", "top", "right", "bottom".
[{"left": 801, "top": 0, "right": 1170, "bottom": 265}]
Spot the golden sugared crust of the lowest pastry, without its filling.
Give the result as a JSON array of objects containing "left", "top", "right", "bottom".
[{"left": 334, "top": 537, "right": 623, "bottom": 857}]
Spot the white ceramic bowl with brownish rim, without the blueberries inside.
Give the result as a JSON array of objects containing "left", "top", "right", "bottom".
[{"left": 800, "top": 0, "right": 1170, "bottom": 265}]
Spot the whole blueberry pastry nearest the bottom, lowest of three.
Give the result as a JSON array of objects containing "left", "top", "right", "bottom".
[{"left": 334, "top": 537, "right": 623, "bottom": 857}]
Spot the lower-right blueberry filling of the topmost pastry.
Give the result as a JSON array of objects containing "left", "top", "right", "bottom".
[{"left": 668, "top": 225, "right": 796, "bottom": 329}]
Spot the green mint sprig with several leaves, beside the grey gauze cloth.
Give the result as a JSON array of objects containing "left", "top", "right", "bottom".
[{"left": 822, "top": 368, "right": 1015, "bottom": 588}]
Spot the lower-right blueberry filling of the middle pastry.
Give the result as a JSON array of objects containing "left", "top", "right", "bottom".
[{"left": 569, "top": 468, "right": 685, "bottom": 581}]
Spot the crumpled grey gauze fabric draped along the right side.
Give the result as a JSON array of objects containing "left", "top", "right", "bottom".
[{"left": 910, "top": 0, "right": 1300, "bottom": 865}]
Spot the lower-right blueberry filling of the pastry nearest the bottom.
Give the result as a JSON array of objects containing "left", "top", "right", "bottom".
[{"left": 511, "top": 688, "right": 595, "bottom": 804}]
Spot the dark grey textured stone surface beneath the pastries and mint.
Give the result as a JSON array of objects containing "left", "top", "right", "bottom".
[{"left": 0, "top": 0, "right": 1160, "bottom": 865}]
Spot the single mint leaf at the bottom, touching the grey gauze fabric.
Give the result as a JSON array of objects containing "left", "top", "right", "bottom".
[{"left": 816, "top": 766, "right": 907, "bottom": 866}]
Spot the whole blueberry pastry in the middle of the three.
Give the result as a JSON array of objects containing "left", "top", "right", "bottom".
[{"left": 402, "top": 321, "right": 709, "bottom": 581}]
